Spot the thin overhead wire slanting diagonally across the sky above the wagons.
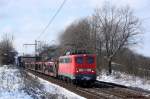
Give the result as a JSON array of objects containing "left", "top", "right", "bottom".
[{"left": 36, "top": 0, "right": 67, "bottom": 39}]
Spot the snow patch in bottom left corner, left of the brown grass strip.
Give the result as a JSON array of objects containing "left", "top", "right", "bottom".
[{"left": 0, "top": 65, "right": 32, "bottom": 99}]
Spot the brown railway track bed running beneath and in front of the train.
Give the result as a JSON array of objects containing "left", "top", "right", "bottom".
[{"left": 27, "top": 70, "right": 150, "bottom": 99}]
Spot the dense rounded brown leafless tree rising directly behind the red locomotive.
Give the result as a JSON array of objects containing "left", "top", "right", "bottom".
[{"left": 60, "top": 19, "right": 92, "bottom": 52}]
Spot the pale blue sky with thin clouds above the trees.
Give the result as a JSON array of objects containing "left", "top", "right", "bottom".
[{"left": 0, "top": 0, "right": 150, "bottom": 56}]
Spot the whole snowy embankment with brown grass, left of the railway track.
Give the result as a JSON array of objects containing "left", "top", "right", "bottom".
[{"left": 0, "top": 65, "right": 85, "bottom": 99}]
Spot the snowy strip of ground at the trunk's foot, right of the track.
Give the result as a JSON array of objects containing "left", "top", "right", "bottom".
[{"left": 97, "top": 70, "right": 150, "bottom": 91}]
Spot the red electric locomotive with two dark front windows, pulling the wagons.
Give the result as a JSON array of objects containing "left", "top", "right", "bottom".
[{"left": 58, "top": 51, "right": 96, "bottom": 83}]
